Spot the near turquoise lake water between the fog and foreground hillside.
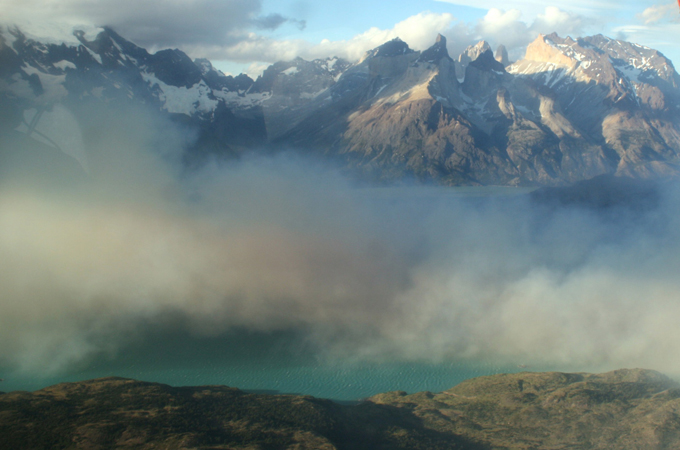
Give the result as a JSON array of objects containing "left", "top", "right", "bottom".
[{"left": 0, "top": 326, "right": 554, "bottom": 401}]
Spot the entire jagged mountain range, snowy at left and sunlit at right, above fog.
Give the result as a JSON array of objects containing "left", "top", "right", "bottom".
[{"left": 0, "top": 26, "right": 680, "bottom": 186}]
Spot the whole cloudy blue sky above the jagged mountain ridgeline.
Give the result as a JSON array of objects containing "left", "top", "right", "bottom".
[{"left": 0, "top": 0, "right": 680, "bottom": 76}]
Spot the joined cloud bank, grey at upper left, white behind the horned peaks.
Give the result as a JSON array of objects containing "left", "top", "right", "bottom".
[{"left": 0, "top": 0, "right": 592, "bottom": 68}]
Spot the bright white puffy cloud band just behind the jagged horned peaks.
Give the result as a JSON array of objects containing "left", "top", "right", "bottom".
[{"left": 202, "top": 7, "right": 592, "bottom": 70}]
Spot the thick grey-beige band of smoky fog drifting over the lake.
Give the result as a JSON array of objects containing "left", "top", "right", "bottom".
[{"left": 0, "top": 103, "right": 680, "bottom": 394}]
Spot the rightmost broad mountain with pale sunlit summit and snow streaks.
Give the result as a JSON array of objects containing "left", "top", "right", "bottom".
[{"left": 508, "top": 34, "right": 680, "bottom": 181}]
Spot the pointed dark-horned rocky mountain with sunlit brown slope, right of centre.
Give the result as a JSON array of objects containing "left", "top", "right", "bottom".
[{"left": 282, "top": 37, "right": 514, "bottom": 184}]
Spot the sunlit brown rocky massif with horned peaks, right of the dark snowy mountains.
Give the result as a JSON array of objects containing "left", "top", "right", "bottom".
[{"left": 284, "top": 35, "right": 680, "bottom": 185}]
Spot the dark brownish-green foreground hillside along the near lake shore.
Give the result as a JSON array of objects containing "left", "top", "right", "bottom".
[{"left": 0, "top": 369, "right": 680, "bottom": 450}]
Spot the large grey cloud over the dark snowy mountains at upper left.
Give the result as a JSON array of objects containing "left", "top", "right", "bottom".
[{"left": 0, "top": 0, "right": 300, "bottom": 50}]
